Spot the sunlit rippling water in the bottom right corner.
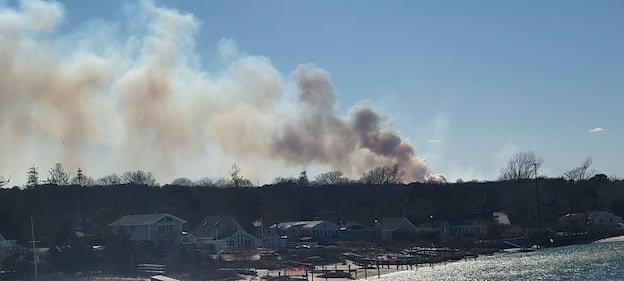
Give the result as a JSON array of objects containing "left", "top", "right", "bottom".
[{"left": 371, "top": 242, "right": 624, "bottom": 281}]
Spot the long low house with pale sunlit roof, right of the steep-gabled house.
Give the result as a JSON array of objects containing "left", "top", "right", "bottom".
[{"left": 268, "top": 220, "right": 340, "bottom": 248}]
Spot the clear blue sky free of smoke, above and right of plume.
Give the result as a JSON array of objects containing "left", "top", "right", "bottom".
[{"left": 1, "top": 1, "right": 624, "bottom": 183}]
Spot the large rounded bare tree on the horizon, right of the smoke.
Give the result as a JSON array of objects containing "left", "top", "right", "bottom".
[{"left": 499, "top": 151, "right": 544, "bottom": 180}]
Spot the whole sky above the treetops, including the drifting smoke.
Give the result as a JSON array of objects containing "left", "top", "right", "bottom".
[{"left": 0, "top": 0, "right": 624, "bottom": 184}]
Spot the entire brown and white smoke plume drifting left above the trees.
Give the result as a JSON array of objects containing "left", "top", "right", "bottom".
[{"left": 0, "top": 0, "right": 433, "bottom": 184}]
